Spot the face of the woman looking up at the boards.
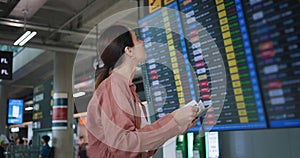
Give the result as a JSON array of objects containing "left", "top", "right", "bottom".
[{"left": 130, "top": 30, "right": 147, "bottom": 62}]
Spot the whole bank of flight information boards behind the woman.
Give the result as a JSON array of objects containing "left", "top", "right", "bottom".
[{"left": 138, "top": 0, "right": 300, "bottom": 132}]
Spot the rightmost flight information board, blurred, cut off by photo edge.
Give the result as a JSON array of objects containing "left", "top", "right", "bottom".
[{"left": 243, "top": 0, "right": 300, "bottom": 128}]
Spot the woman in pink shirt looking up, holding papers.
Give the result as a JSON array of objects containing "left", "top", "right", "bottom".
[{"left": 87, "top": 25, "right": 199, "bottom": 158}]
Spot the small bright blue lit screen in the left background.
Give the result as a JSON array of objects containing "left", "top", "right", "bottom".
[{"left": 7, "top": 99, "right": 24, "bottom": 124}]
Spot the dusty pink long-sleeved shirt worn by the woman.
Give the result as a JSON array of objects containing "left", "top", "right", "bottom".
[{"left": 87, "top": 72, "right": 187, "bottom": 158}]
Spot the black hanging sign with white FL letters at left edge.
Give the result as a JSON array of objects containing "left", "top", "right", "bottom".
[{"left": 0, "top": 51, "right": 13, "bottom": 80}]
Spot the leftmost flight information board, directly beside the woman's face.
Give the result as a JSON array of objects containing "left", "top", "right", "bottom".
[{"left": 138, "top": 1, "right": 196, "bottom": 121}]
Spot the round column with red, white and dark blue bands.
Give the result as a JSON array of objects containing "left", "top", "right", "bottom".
[{"left": 52, "top": 52, "right": 76, "bottom": 157}]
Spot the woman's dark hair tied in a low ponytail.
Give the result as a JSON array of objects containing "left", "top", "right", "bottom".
[{"left": 95, "top": 25, "right": 134, "bottom": 89}]
